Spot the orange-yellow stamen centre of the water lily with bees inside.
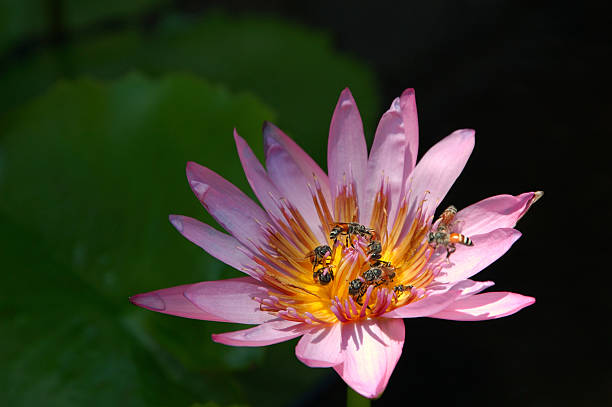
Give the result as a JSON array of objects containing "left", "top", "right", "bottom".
[{"left": 253, "top": 177, "right": 437, "bottom": 324}]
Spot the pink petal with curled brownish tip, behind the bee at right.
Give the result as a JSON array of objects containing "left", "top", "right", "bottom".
[{"left": 456, "top": 192, "right": 537, "bottom": 236}]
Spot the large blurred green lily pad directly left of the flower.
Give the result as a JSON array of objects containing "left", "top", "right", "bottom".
[{"left": 0, "top": 75, "right": 274, "bottom": 406}]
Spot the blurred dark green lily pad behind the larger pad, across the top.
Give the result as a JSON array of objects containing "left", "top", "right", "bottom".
[{"left": 0, "top": 12, "right": 379, "bottom": 155}]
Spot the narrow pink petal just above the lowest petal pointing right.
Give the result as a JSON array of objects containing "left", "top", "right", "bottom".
[{"left": 383, "top": 280, "right": 487, "bottom": 318}]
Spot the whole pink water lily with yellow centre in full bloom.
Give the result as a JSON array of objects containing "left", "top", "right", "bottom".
[{"left": 131, "top": 89, "right": 541, "bottom": 398}]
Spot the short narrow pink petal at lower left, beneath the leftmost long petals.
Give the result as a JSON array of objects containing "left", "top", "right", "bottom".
[{"left": 212, "top": 319, "right": 308, "bottom": 346}]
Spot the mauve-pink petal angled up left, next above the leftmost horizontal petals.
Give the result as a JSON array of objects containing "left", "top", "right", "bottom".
[{"left": 169, "top": 215, "right": 258, "bottom": 278}]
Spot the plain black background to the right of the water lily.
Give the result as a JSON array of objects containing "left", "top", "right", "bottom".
[{"left": 284, "top": 1, "right": 612, "bottom": 406}]
